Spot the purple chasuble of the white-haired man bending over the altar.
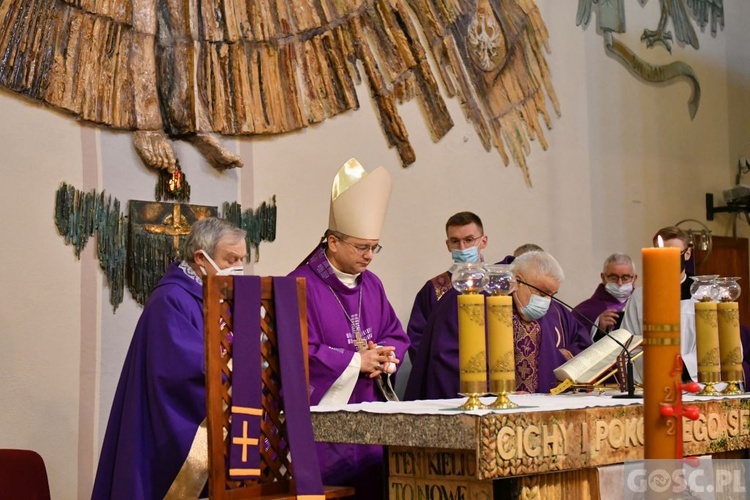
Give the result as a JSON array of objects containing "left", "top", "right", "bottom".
[{"left": 404, "top": 262, "right": 591, "bottom": 400}]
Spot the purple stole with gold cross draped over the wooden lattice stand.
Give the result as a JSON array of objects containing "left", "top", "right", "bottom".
[{"left": 229, "top": 276, "right": 323, "bottom": 498}]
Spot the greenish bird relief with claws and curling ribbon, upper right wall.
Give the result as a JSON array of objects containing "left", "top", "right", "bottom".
[{"left": 576, "top": 0, "right": 724, "bottom": 119}]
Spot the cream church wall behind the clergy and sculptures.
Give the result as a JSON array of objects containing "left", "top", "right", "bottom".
[{"left": 0, "top": 0, "right": 750, "bottom": 499}]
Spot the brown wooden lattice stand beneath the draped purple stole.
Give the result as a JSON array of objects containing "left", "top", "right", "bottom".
[{"left": 203, "top": 276, "right": 354, "bottom": 500}]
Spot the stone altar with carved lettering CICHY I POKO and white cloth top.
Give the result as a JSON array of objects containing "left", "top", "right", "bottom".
[{"left": 312, "top": 394, "right": 750, "bottom": 499}]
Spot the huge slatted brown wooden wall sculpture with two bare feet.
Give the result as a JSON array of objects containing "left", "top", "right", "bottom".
[{"left": 0, "top": 0, "right": 560, "bottom": 185}]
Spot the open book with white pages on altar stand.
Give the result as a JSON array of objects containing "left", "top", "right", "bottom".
[{"left": 555, "top": 328, "right": 643, "bottom": 385}]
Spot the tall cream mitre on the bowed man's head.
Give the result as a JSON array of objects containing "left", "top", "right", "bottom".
[{"left": 328, "top": 158, "right": 391, "bottom": 240}]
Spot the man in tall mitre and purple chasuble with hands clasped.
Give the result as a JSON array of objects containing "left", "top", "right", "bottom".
[{"left": 290, "top": 159, "right": 409, "bottom": 498}]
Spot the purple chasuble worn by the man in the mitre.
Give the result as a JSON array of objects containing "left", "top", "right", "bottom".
[{"left": 289, "top": 245, "right": 409, "bottom": 498}]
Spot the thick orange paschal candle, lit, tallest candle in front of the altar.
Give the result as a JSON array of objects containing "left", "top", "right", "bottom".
[{"left": 641, "top": 248, "right": 682, "bottom": 459}]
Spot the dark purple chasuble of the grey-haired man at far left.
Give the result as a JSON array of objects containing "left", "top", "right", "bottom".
[{"left": 92, "top": 263, "right": 212, "bottom": 500}]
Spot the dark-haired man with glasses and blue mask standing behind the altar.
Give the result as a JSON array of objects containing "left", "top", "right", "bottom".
[{"left": 406, "top": 212, "right": 487, "bottom": 361}]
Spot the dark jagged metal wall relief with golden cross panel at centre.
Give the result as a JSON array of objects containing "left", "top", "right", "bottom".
[{"left": 55, "top": 183, "right": 276, "bottom": 311}]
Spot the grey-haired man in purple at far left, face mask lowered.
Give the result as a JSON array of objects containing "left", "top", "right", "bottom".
[{"left": 91, "top": 218, "right": 247, "bottom": 500}]
